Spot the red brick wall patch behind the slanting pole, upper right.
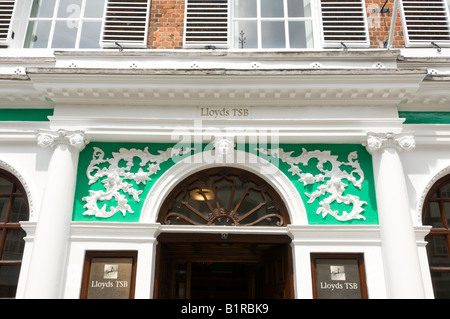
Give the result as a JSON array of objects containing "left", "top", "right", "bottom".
[{"left": 366, "top": 0, "right": 405, "bottom": 49}]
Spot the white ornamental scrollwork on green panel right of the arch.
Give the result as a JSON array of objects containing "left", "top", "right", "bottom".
[{"left": 257, "top": 148, "right": 367, "bottom": 221}]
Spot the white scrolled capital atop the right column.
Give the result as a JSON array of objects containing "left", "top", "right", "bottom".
[{"left": 365, "top": 132, "right": 416, "bottom": 153}]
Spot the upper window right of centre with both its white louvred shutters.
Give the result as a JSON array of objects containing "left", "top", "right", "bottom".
[{"left": 184, "top": 0, "right": 369, "bottom": 50}]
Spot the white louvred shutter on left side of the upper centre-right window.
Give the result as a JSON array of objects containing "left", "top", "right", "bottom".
[{"left": 184, "top": 0, "right": 229, "bottom": 48}]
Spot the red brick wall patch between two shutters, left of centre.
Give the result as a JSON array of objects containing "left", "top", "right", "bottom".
[{"left": 148, "top": 0, "right": 185, "bottom": 49}]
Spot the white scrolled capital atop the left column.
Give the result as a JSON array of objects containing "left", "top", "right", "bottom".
[{"left": 37, "top": 129, "right": 89, "bottom": 151}]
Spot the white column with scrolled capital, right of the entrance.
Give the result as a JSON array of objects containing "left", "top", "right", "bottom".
[{"left": 367, "top": 133, "right": 425, "bottom": 299}]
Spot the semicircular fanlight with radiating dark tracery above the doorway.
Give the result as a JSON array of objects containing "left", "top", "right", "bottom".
[{"left": 159, "top": 168, "right": 289, "bottom": 226}]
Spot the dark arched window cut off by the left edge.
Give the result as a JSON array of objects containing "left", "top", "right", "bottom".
[{"left": 0, "top": 170, "right": 29, "bottom": 298}]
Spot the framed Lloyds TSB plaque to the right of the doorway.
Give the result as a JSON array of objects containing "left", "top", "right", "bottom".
[{"left": 311, "top": 254, "right": 367, "bottom": 299}]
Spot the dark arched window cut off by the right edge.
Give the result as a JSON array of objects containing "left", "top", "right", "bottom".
[{"left": 423, "top": 175, "right": 450, "bottom": 299}]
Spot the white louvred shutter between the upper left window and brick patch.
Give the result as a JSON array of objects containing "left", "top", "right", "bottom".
[{"left": 100, "top": 0, "right": 151, "bottom": 48}]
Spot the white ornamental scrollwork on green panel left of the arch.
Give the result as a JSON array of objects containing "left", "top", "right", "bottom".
[{"left": 82, "top": 147, "right": 192, "bottom": 218}]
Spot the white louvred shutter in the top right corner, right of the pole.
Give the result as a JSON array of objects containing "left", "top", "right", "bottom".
[{"left": 401, "top": 0, "right": 450, "bottom": 47}]
